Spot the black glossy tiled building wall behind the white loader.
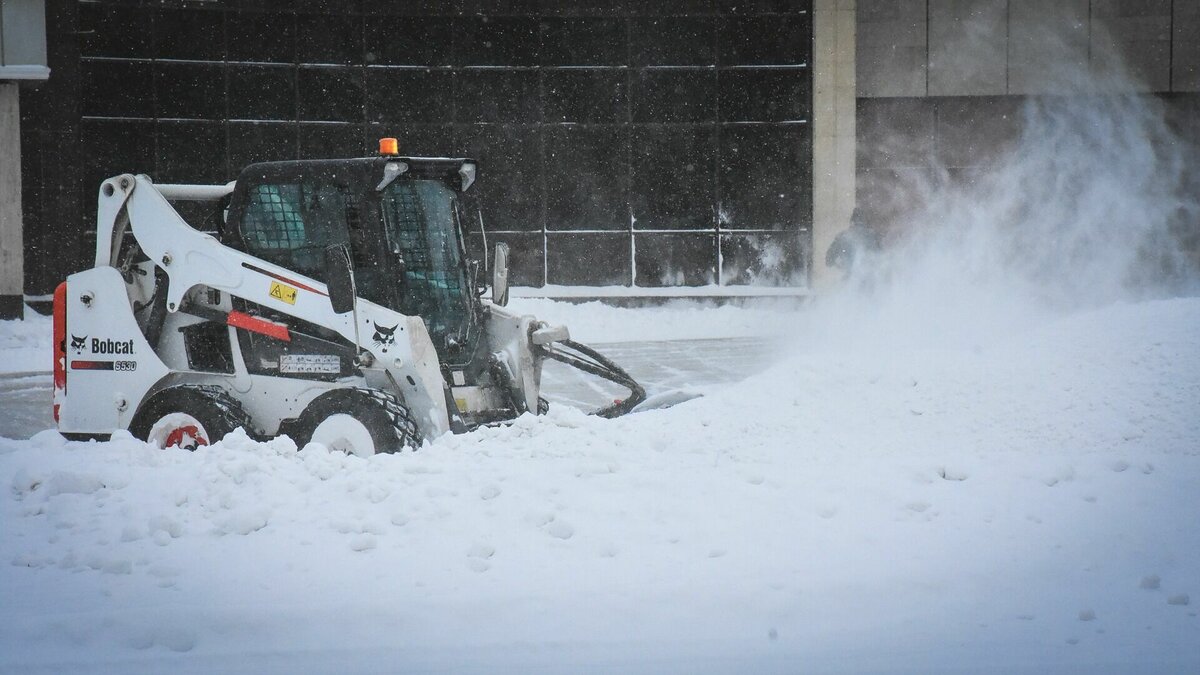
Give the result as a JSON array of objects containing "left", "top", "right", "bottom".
[{"left": 22, "top": 0, "right": 812, "bottom": 293}]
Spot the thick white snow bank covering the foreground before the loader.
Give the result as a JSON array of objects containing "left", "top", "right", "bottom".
[{"left": 0, "top": 291, "right": 1200, "bottom": 673}]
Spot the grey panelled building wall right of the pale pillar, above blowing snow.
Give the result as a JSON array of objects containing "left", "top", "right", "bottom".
[{"left": 857, "top": 0, "right": 1200, "bottom": 223}]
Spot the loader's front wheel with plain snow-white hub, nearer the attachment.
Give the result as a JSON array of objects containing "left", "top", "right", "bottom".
[{"left": 295, "top": 389, "right": 421, "bottom": 456}]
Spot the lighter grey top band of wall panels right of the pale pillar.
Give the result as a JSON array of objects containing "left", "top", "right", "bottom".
[{"left": 858, "top": 0, "right": 1200, "bottom": 98}]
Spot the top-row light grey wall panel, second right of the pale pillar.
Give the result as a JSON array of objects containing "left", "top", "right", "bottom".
[{"left": 929, "top": 0, "right": 1008, "bottom": 96}]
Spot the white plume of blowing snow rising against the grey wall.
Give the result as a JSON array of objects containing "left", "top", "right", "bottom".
[{"left": 820, "top": 26, "right": 1200, "bottom": 345}]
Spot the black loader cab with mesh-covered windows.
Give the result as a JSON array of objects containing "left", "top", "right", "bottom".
[{"left": 223, "top": 156, "right": 481, "bottom": 363}]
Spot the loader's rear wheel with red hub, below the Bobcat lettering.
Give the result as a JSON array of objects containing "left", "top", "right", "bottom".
[{"left": 130, "top": 387, "right": 253, "bottom": 450}]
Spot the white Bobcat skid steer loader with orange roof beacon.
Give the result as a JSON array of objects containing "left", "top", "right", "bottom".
[{"left": 54, "top": 139, "right": 644, "bottom": 455}]
